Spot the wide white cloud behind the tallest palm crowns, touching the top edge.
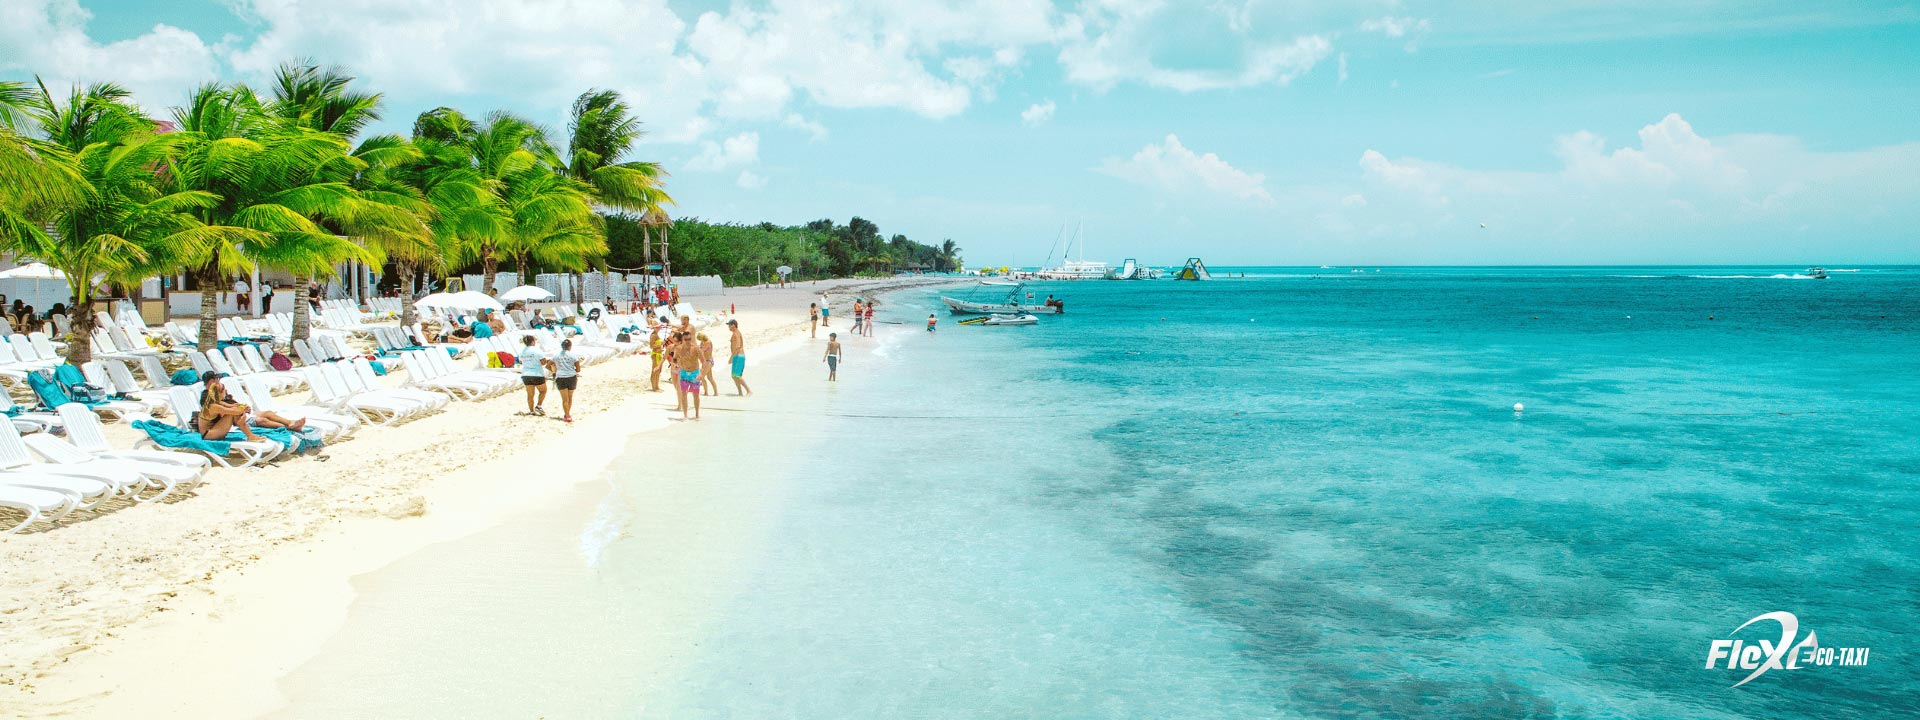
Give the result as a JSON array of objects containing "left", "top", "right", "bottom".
[{"left": 227, "top": 0, "right": 710, "bottom": 142}]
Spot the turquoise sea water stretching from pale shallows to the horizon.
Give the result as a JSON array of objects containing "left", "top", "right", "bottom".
[{"left": 647, "top": 267, "right": 1920, "bottom": 718}]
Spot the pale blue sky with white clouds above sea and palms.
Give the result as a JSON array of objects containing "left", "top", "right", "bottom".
[{"left": 0, "top": 0, "right": 1920, "bottom": 265}]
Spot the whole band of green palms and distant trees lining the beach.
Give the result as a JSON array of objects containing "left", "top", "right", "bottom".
[{"left": 0, "top": 63, "right": 960, "bottom": 363}]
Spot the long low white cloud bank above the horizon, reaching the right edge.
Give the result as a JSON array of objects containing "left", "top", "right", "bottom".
[{"left": 1327, "top": 113, "right": 1920, "bottom": 259}]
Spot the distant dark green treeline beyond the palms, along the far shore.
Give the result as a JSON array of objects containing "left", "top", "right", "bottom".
[{"left": 605, "top": 213, "right": 960, "bottom": 284}]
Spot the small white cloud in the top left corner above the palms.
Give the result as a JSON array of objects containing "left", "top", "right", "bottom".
[{"left": 0, "top": 0, "right": 219, "bottom": 117}]
